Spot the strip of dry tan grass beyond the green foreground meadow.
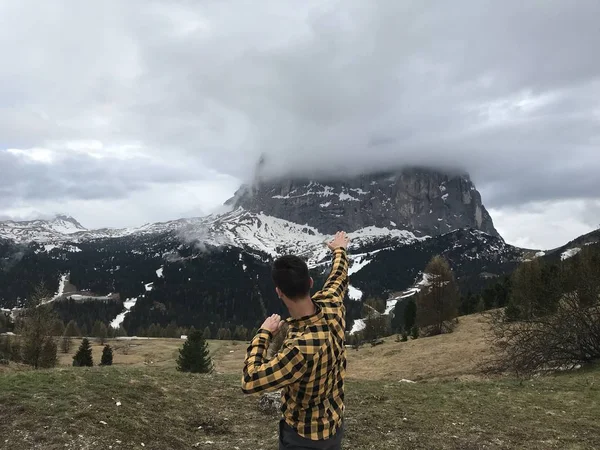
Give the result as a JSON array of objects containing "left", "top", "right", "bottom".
[{"left": 54, "top": 314, "right": 488, "bottom": 380}]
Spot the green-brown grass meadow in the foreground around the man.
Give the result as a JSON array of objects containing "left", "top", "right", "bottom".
[{"left": 0, "top": 362, "right": 600, "bottom": 450}]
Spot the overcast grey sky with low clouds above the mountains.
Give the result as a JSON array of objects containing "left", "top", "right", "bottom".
[{"left": 0, "top": 0, "right": 600, "bottom": 248}]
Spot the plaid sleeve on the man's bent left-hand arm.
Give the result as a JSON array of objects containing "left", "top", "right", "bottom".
[{"left": 242, "top": 329, "right": 306, "bottom": 394}]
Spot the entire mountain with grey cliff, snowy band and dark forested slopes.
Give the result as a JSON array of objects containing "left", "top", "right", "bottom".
[{"left": 0, "top": 169, "right": 531, "bottom": 333}]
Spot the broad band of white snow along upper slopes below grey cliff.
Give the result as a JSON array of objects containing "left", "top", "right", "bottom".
[{"left": 0, "top": 208, "right": 427, "bottom": 273}]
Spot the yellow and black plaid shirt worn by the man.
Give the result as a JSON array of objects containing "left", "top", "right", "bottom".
[{"left": 242, "top": 248, "right": 348, "bottom": 440}]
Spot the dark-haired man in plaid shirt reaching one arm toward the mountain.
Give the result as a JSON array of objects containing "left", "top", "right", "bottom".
[{"left": 242, "top": 232, "right": 350, "bottom": 450}]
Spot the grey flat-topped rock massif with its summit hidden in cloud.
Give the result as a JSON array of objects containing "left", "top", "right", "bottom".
[{"left": 228, "top": 168, "right": 499, "bottom": 236}]
